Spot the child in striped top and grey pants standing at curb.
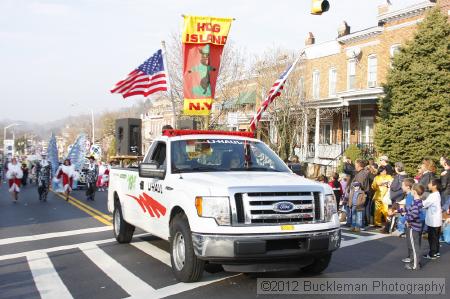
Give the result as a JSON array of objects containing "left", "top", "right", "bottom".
[{"left": 402, "top": 184, "right": 425, "bottom": 270}]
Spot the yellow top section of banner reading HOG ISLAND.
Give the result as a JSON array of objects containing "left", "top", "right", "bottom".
[{"left": 182, "top": 16, "right": 233, "bottom": 46}]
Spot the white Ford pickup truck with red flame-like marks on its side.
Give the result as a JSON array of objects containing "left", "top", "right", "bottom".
[{"left": 108, "top": 130, "right": 341, "bottom": 282}]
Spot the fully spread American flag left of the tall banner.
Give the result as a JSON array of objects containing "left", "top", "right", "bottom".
[{"left": 111, "top": 49, "right": 167, "bottom": 98}]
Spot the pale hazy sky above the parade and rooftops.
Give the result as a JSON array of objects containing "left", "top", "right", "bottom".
[{"left": 0, "top": 0, "right": 420, "bottom": 122}]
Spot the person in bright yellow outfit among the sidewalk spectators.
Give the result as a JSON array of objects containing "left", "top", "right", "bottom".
[{"left": 372, "top": 166, "right": 393, "bottom": 227}]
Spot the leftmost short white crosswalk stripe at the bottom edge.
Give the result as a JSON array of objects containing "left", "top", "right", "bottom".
[{"left": 27, "top": 252, "right": 73, "bottom": 299}]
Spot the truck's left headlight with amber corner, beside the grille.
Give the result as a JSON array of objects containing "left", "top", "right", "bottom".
[{"left": 195, "top": 196, "right": 231, "bottom": 225}]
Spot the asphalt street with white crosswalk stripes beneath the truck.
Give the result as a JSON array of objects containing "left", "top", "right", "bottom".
[{"left": 0, "top": 184, "right": 450, "bottom": 299}]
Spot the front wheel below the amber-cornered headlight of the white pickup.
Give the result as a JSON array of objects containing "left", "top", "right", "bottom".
[{"left": 170, "top": 214, "right": 205, "bottom": 282}]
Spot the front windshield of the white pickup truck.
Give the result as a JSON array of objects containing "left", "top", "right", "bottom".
[{"left": 171, "top": 139, "right": 289, "bottom": 173}]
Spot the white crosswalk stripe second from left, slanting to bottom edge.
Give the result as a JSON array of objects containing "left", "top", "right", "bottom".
[{"left": 80, "top": 244, "right": 156, "bottom": 298}]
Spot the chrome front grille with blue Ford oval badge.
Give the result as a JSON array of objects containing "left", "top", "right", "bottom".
[{"left": 234, "top": 192, "right": 322, "bottom": 225}]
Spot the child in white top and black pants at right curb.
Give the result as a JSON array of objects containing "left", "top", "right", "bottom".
[{"left": 423, "top": 179, "right": 442, "bottom": 260}]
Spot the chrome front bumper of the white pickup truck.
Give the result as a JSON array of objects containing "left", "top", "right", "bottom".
[{"left": 192, "top": 228, "right": 341, "bottom": 263}]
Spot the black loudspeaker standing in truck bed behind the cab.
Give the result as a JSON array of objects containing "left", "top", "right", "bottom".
[{"left": 116, "top": 118, "right": 142, "bottom": 156}]
